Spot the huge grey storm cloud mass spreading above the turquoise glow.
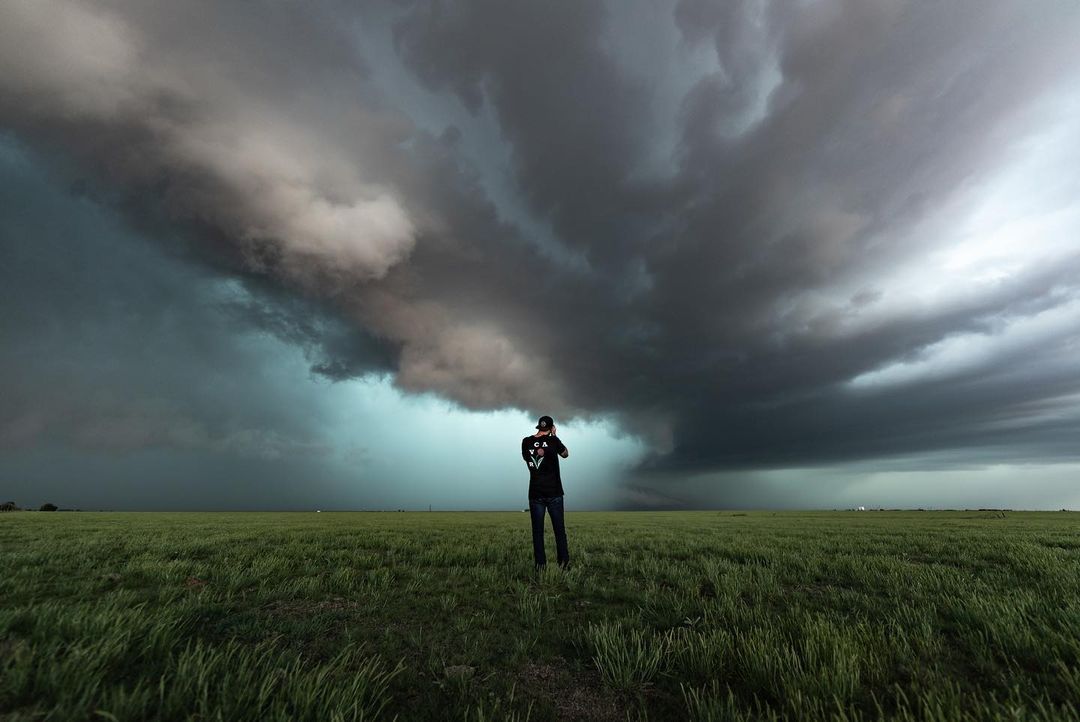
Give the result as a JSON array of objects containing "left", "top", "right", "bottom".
[{"left": 0, "top": 0, "right": 1080, "bottom": 499}]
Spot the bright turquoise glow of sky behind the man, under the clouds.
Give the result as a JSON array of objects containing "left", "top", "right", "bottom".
[{"left": 324, "top": 369, "right": 645, "bottom": 509}]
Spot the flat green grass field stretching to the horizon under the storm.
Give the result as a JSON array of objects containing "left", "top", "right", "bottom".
[{"left": 0, "top": 509, "right": 1080, "bottom": 721}]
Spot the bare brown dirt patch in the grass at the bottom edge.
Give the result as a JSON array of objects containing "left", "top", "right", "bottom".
[{"left": 517, "top": 657, "right": 626, "bottom": 722}]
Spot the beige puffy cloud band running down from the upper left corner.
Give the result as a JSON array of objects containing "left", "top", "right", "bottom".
[{"left": 0, "top": 0, "right": 415, "bottom": 278}]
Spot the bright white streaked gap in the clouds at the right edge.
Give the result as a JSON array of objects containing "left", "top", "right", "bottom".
[{"left": 846, "top": 91, "right": 1080, "bottom": 389}]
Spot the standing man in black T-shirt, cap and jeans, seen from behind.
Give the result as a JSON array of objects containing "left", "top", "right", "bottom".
[{"left": 522, "top": 417, "right": 570, "bottom": 569}]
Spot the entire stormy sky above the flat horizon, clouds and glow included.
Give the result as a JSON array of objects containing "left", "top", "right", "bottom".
[{"left": 0, "top": 0, "right": 1080, "bottom": 509}]
